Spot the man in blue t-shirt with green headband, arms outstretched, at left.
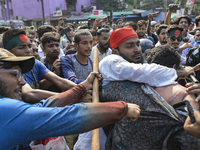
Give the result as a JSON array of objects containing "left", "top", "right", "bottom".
[{"left": 3, "top": 29, "right": 76, "bottom": 103}]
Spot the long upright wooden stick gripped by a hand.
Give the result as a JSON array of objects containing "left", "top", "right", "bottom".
[{"left": 91, "top": 48, "right": 100, "bottom": 150}]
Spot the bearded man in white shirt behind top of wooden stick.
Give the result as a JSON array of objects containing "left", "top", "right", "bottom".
[{"left": 90, "top": 28, "right": 112, "bottom": 61}]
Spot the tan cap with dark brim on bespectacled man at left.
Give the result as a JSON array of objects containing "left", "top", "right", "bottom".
[{"left": 0, "top": 48, "right": 35, "bottom": 73}]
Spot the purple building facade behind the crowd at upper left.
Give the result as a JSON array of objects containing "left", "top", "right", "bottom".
[{"left": 0, "top": 0, "right": 96, "bottom": 24}]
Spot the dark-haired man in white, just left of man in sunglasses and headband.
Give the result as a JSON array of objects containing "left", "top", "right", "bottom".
[{"left": 155, "top": 24, "right": 168, "bottom": 47}]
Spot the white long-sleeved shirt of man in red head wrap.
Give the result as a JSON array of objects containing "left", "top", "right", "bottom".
[{"left": 99, "top": 54, "right": 177, "bottom": 87}]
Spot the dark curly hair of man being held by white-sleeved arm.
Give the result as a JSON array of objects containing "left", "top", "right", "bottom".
[{"left": 146, "top": 45, "right": 181, "bottom": 68}]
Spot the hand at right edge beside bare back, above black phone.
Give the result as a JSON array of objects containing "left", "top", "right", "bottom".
[{"left": 185, "top": 82, "right": 200, "bottom": 102}]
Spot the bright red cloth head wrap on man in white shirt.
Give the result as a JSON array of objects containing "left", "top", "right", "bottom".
[{"left": 110, "top": 26, "right": 138, "bottom": 48}]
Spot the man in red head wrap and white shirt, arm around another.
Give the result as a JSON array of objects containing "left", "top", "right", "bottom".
[{"left": 100, "top": 26, "right": 194, "bottom": 87}]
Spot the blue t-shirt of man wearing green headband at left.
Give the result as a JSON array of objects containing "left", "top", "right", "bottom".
[{"left": 24, "top": 59, "right": 49, "bottom": 89}]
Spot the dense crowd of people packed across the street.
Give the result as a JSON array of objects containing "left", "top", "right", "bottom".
[{"left": 0, "top": 4, "right": 200, "bottom": 150}]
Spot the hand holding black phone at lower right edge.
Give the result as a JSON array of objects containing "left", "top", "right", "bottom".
[{"left": 183, "top": 111, "right": 200, "bottom": 138}]
